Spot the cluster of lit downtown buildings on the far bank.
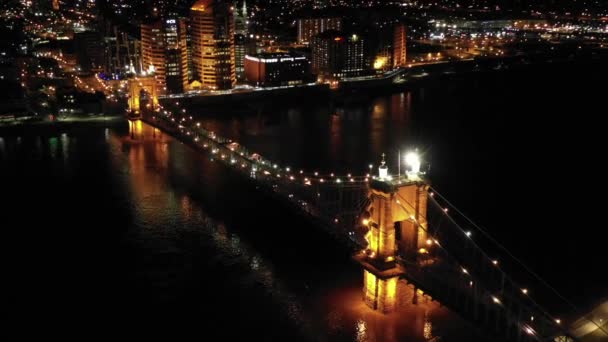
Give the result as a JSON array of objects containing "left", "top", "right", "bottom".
[{"left": 4, "top": 0, "right": 414, "bottom": 109}]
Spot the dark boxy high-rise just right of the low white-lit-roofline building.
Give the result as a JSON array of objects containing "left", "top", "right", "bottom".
[{"left": 311, "top": 30, "right": 370, "bottom": 78}]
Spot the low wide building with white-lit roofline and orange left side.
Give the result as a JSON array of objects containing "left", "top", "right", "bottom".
[{"left": 245, "top": 53, "right": 311, "bottom": 86}]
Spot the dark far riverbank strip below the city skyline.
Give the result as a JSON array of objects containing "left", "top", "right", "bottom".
[{"left": 160, "top": 50, "right": 608, "bottom": 112}]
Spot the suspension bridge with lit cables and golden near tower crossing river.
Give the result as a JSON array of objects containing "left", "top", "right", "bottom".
[{"left": 128, "top": 103, "right": 608, "bottom": 341}]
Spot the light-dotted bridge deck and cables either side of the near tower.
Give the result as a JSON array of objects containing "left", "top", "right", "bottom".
[{"left": 137, "top": 108, "right": 584, "bottom": 341}]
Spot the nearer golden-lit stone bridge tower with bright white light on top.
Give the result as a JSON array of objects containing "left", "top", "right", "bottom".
[{"left": 355, "top": 154, "right": 429, "bottom": 313}]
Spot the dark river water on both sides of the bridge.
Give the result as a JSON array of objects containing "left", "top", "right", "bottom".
[{"left": 0, "top": 58, "right": 608, "bottom": 341}]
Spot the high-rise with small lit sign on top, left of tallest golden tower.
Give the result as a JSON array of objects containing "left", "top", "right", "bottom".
[{"left": 141, "top": 18, "right": 188, "bottom": 94}]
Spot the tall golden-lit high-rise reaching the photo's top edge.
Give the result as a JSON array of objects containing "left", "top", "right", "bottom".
[{"left": 190, "top": 0, "right": 236, "bottom": 89}]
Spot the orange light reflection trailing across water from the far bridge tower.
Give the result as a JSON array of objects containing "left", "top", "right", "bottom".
[{"left": 110, "top": 123, "right": 324, "bottom": 333}]
